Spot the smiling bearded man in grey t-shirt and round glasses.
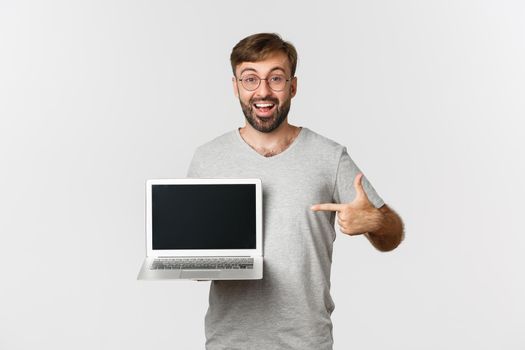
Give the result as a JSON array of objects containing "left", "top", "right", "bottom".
[{"left": 188, "top": 33, "right": 403, "bottom": 350}]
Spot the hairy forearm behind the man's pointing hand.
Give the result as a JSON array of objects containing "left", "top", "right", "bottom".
[{"left": 365, "top": 204, "right": 404, "bottom": 252}]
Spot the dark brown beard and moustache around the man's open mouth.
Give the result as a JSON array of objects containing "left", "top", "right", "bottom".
[{"left": 239, "top": 98, "right": 291, "bottom": 133}]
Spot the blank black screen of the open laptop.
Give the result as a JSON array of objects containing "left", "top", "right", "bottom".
[{"left": 151, "top": 184, "right": 256, "bottom": 250}]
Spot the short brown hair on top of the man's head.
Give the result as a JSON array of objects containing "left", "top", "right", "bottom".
[{"left": 230, "top": 33, "right": 297, "bottom": 77}]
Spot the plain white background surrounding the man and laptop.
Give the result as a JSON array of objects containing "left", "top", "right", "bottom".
[{"left": 0, "top": 0, "right": 525, "bottom": 350}]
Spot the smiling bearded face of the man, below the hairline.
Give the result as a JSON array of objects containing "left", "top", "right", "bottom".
[{"left": 233, "top": 52, "right": 297, "bottom": 133}]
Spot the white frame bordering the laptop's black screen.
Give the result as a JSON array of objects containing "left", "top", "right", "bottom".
[{"left": 146, "top": 178, "right": 263, "bottom": 257}]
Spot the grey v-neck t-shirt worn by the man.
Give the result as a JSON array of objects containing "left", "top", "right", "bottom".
[{"left": 188, "top": 127, "right": 384, "bottom": 350}]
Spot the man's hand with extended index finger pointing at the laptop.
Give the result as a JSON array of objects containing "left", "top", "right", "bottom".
[{"left": 310, "top": 174, "right": 383, "bottom": 236}]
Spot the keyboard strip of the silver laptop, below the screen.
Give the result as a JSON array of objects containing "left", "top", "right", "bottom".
[{"left": 150, "top": 257, "right": 253, "bottom": 270}]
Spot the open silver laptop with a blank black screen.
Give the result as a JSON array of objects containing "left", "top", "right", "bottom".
[{"left": 137, "top": 178, "right": 263, "bottom": 280}]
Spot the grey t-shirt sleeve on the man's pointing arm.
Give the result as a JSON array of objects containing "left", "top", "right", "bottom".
[{"left": 334, "top": 147, "right": 385, "bottom": 208}]
